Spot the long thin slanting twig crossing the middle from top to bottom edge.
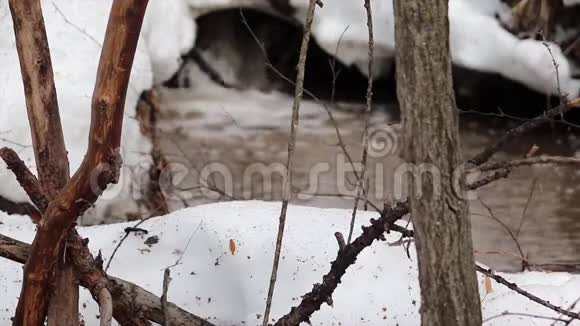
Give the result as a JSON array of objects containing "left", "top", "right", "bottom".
[{"left": 262, "top": 0, "right": 317, "bottom": 326}]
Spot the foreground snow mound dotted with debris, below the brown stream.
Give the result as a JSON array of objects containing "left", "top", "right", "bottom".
[{"left": 0, "top": 201, "right": 580, "bottom": 326}]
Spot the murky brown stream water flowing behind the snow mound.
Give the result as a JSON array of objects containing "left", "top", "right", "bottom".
[{"left": 157, "top": 84, "right": 580, "bottom": 271}]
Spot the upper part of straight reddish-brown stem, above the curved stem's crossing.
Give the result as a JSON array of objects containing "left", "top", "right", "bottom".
[{"left": 9, "top": 0, "right": 69, "bottom": 197}]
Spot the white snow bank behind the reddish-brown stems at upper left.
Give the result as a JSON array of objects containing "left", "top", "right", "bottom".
[{"left": 0, "top": 0, "right": 194, "bottom": 222}]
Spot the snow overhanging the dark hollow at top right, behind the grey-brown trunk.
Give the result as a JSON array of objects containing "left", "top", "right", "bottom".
[{"left": 291, "top": 0, "right": 580, "bottom": 96}]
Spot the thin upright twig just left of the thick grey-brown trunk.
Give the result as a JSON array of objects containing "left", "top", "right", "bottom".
[{"left": 347, "top": 0, "right": 375, "bottom": 243}]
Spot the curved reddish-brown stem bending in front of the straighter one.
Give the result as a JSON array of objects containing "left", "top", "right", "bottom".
[{"left": 11, "top": 0, "right": 147, "bottom": 326}]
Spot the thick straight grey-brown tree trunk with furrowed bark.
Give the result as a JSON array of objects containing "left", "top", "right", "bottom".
[{"left": 394, "top": 0, "right": 481, "bottom": 326}]
